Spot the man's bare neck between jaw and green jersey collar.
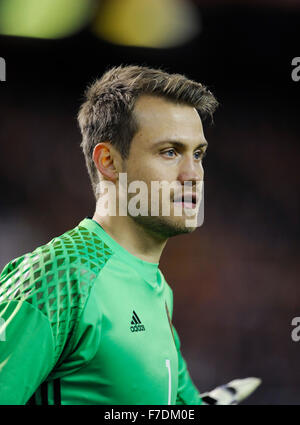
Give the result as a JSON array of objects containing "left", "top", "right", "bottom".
[{"left": 93, "top": 210, "right": 167, "bottom": 263}]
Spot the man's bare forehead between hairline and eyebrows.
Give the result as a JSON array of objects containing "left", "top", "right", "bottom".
[{"left": 134, "top": 95, "right": 204, "bottom": 143}]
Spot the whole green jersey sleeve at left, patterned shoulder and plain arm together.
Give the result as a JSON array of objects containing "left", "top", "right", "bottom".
[{"left": 0, "top": 230, "right": 105, "bottom": 404}]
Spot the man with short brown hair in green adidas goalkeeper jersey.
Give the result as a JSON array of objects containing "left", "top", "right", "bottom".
[{"left": 0, "top": 66, "right": 260, "bottom": 405}]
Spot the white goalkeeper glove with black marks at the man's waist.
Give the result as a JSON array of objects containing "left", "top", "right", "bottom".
[{"left": 200, "top": 378, "right": 261, "bottom": 405}]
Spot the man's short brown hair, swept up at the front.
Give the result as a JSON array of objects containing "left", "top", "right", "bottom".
[{"left": 78, "top": 65, "right": 218, "bottom": 197}]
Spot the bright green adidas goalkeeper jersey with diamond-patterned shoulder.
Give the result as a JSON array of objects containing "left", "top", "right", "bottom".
[{"left": 0, "top": 218, "right": 202, "bottom": 405}]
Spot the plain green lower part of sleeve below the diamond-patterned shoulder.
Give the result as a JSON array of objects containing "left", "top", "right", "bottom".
[{"left": 0, "top": 301, "right": 55, "bottom": 405}]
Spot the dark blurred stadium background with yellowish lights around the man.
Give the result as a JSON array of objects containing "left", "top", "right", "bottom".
[{"left": 0, "top": 0, "right": 300, "bottom": 404}]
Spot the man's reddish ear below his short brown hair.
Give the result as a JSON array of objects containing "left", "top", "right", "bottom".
[{"left": 93, "top": 142, "right": 118, "bottom": 182}]
